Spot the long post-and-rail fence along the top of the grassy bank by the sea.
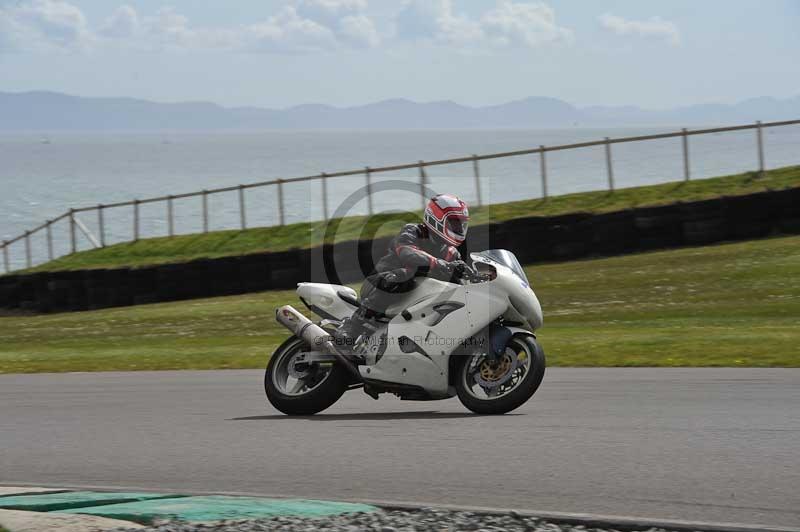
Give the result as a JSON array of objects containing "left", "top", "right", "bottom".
[{"left": 0, "top": 120, "right": 800, "bottom": 273}]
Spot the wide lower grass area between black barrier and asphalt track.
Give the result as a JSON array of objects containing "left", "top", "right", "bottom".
[{"left": 0, "top": 236, "right": 800, "bottom": 373}]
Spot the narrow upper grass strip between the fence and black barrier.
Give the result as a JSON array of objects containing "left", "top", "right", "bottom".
[{"left": 23, "top": 166, "right": 800, "bottom": 271}]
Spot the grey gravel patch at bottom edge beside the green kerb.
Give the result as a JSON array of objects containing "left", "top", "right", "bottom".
[{"left": 106, "top": 509, "right": 684, "bottom": 532}]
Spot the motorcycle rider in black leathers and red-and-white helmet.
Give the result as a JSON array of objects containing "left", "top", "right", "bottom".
[{"left": 336, "top": 194, "right": 469, "bottom": 344}]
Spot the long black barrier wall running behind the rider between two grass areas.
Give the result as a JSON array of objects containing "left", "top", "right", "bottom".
[{"left": 0, "top": 188, "right": 800, "bottom": 312}]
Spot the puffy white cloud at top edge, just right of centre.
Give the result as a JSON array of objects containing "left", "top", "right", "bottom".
[{"left": 396, "top": 0, "right": 572, "bottom": 47}]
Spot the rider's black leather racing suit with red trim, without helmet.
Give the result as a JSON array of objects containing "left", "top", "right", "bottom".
[{"left": 359, "top": 224, "right": 461, "bottom": 318}]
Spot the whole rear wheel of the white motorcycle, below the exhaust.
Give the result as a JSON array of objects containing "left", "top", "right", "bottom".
[{"left": 264, "top": 336, "right": 348, "bottom": 416}]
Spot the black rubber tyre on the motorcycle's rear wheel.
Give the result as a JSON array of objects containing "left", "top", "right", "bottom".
[{"left": 264, "top": 336, "right": 348, "bottom": 416}]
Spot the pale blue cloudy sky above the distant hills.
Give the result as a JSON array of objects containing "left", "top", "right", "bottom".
[{"left": 0, "top": 0, "right": 800, "bottom": 109}]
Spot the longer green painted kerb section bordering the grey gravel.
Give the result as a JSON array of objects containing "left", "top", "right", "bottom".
[{"left": 60, "top": 496, "right": 377, "bottom": 524}]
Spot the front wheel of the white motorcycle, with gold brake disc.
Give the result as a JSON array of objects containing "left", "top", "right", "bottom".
[{"left": 455, "top": 335, "right": 546, "bottom": 415}]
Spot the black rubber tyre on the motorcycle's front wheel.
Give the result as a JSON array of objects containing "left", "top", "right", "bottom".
[{"left": 455, "top": 335, "right": 546, "bottom": 415}]
